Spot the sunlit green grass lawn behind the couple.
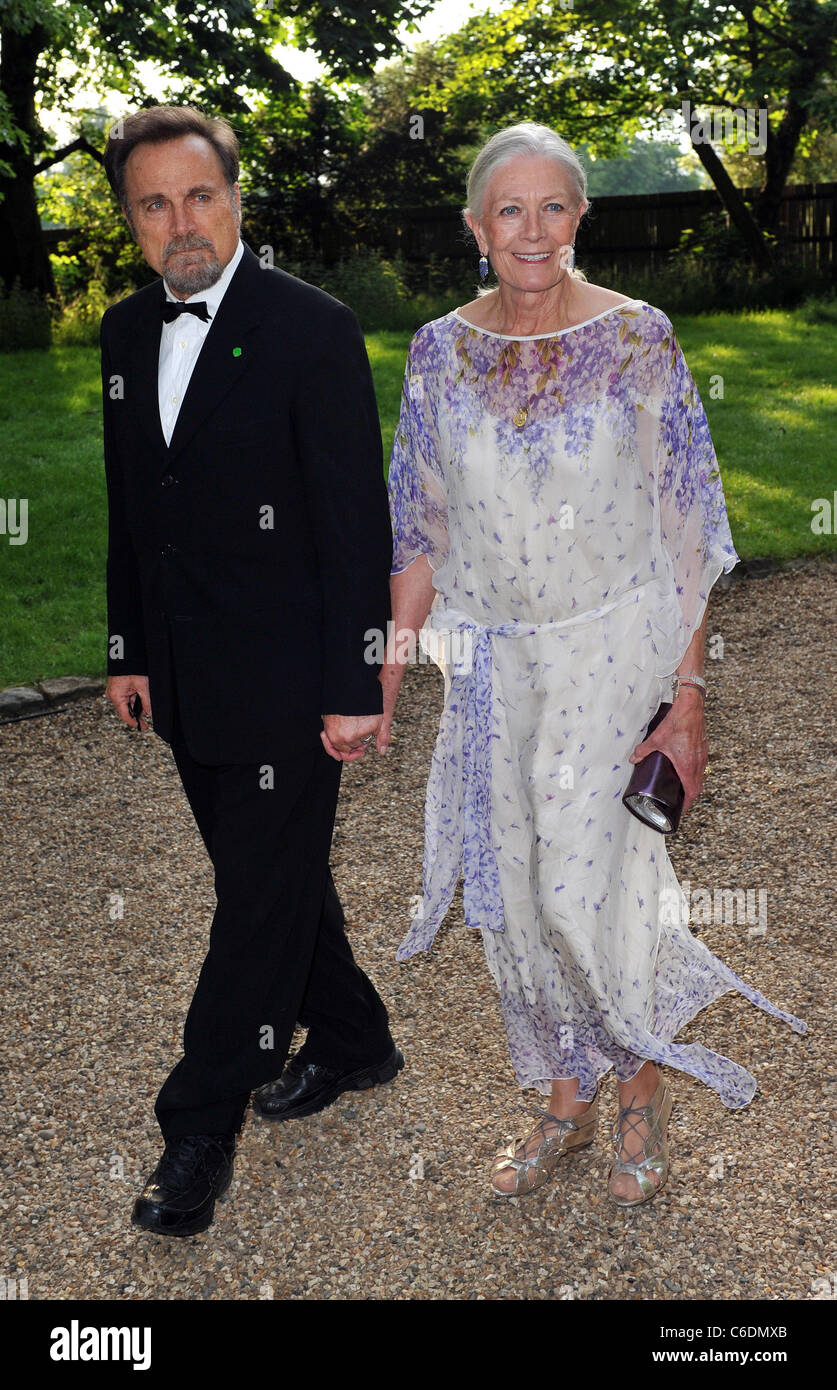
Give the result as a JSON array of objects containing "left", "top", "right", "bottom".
[{"left": 0, "top": 310, "right": 837, "bottom": 688}]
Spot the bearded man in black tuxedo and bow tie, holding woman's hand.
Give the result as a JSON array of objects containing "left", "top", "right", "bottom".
[{"left": 101, "top": 107, "right": 403, "bottom": 1236}]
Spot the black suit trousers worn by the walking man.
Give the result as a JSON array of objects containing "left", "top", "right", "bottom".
[{"left": 154, "top": 661, "right": 392, "bottom": 1138}]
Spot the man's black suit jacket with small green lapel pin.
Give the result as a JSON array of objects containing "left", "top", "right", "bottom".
[{"left": 101, "top": 246, "right": 392, "bottom": 765}]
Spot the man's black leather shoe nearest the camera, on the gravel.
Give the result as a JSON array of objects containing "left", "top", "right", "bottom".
[{"left": 131, "top": 1133, "right": 235, "bottom": 1236}]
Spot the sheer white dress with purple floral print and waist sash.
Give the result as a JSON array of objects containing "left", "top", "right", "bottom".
[{"left": 389, "top": 300, "right": 806, "bottom": 1108}]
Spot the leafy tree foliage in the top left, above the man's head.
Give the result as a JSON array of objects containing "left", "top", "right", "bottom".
[{"left": 0, "top": 0, "right": 432, "bottom": 293}]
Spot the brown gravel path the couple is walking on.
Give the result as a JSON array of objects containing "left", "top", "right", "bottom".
[{"left": 0, "top": 563, "right": 837, "bottom": 1300}]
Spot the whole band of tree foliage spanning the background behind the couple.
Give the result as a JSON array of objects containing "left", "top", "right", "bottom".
[{"left": 0, "top": 0, "right": 837, "bottom": 293}]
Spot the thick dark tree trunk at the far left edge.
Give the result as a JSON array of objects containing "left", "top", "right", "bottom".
[{"left": 0, "top": 25, "right": 56, "bottom": 296}]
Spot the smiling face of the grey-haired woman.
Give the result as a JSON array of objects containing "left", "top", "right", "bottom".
[{"left": 467, "top": 154, "right": 585, "bottom": 292}]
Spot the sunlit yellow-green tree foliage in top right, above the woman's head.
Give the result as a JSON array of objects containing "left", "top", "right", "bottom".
[{"left": 383, "top": 0, "right": 837, "bottom": 264}]
